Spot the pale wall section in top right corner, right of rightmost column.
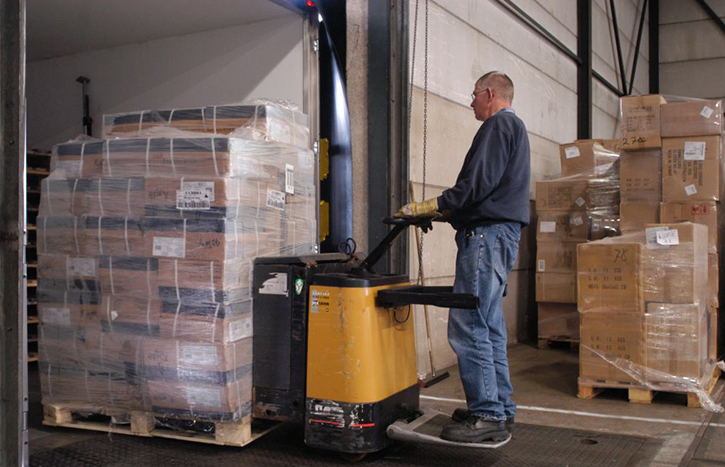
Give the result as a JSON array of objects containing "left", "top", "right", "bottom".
[{"left": 660, "top": 0, "right": 725, "bottom": 99}]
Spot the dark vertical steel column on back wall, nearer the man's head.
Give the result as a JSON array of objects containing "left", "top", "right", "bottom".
[{"left": 577, "top": 0, "right": 592, "bottom": 139}]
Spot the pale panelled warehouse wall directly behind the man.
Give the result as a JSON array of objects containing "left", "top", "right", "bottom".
[{"left": 409, "top": 0, "right": 649, "bottom": 373}]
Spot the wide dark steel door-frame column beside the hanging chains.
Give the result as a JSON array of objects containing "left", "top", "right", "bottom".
[{"left": 367, "top": 0, "right": 408, "bottom": 274}]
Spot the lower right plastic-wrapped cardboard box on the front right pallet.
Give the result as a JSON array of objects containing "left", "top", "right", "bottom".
[{"left": 644, "top": 303, "right": 708, "bottom": 384}]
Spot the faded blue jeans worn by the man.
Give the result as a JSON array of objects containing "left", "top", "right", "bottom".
[{"left": 448, "top": 222, "right": 521, "bottom": 420}]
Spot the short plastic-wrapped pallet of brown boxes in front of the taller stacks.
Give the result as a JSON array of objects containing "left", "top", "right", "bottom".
[{"left": 577, "top": 223, "right": 719, "bottom": 406}]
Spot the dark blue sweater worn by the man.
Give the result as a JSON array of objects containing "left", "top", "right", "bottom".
[{"left": 438, "top": 108, "right": 531, "bottom": 230}]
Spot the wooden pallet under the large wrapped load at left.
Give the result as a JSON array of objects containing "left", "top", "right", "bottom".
[{"left": 43, "top": 405, "right": 280, "bottom": 447}]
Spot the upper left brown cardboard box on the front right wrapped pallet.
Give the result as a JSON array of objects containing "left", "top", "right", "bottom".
[{"left": 577, "top": 242, "right": 645, "bottom": 314}]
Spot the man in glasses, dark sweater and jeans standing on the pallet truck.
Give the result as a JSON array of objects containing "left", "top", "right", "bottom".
[{"left": 396, "top": 71, "right": 531, "bottom": 443}]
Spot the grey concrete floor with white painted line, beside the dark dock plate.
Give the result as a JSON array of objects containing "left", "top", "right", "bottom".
[{"left": 29, "top": 344, "right": 725, "bottom": 467}]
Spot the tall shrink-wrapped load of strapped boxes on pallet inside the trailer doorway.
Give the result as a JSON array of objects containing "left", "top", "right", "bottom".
[{"left": 38, "top": 103, "right": 317, "bottom": 446}]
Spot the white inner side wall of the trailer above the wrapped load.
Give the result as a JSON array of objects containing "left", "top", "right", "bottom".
[{"left": 27, "top": 17, "right": 303, "bottom": 150}]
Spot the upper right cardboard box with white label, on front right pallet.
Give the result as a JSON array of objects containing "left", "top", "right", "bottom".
[{"left": 642, "top": 223, "right": 708, "bottom": 304}]
